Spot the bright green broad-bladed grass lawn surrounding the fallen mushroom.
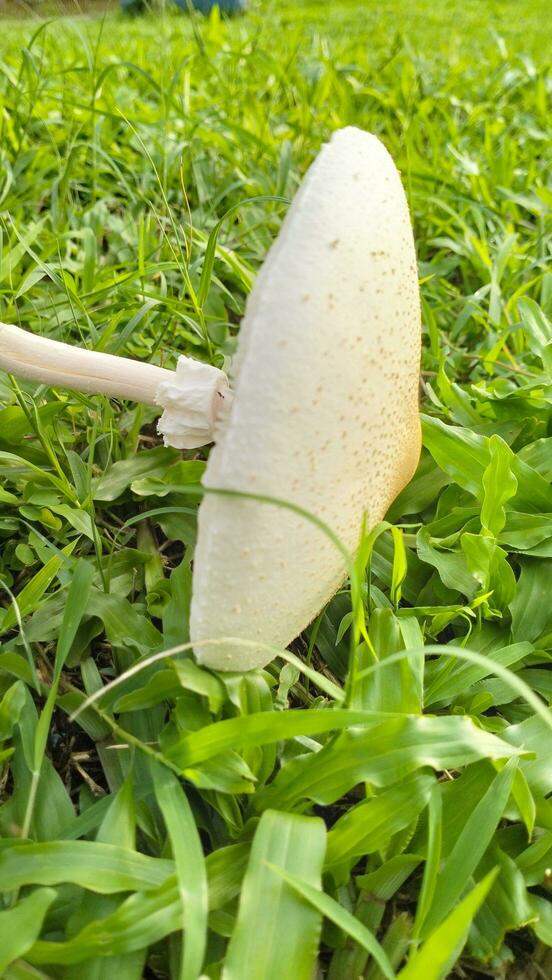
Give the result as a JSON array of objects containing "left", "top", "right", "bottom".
[{"left": 0, "top": 0, "right": 552, "bottom": 980}]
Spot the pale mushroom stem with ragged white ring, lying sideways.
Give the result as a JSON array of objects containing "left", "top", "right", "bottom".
[{"left": 0, "top": 323, "right": 231, "bottom": 449}]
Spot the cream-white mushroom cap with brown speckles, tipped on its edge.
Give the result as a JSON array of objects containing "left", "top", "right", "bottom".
[{"left": 190, "top": 127, "right": 421, "bottom": 671}]
